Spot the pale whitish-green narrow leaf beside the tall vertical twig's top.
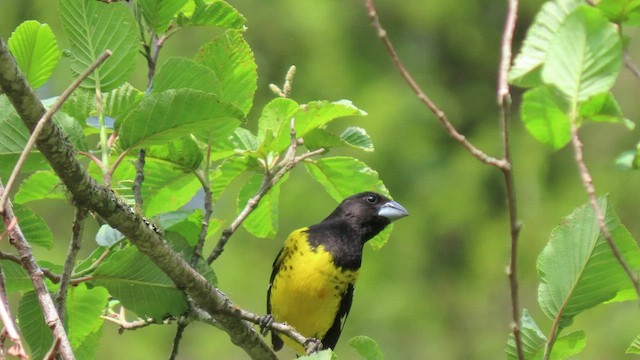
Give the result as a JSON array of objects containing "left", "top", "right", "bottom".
[{"left": 509, "top": 0, "right": 582, "bottom": 87}]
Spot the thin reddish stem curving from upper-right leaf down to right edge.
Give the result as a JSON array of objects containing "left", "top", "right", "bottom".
[{"left": 570, "top": 115, "right": 640, "bottom": 297}]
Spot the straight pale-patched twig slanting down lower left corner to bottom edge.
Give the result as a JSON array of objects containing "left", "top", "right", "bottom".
[{"left": 0, "top": 183, "right": 75, "bottom": 359}]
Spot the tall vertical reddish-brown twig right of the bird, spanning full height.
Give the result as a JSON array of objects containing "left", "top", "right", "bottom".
[{"left": 497, "top": 0, "right": 524, "bottom": 360}]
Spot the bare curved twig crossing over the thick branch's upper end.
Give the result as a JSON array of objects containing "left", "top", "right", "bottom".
[{"left": 0, "top": 50, "right": 111, "bottom": 214}]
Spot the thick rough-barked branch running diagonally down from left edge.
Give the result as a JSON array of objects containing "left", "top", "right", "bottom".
[{"left": 0, "top": 38, "right": 277, "bottom": 359}]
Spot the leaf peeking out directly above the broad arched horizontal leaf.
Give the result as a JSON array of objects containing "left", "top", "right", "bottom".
[{"left": 153, "top": 57, "right": 221, "bottom": 95}]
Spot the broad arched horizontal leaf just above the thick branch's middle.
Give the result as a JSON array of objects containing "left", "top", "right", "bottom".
[{"left": 119, "top": 89, "right": 242, "bottom": 149}]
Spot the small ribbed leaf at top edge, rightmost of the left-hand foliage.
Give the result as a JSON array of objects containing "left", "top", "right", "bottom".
[{"left": 177, "top": 0, "right": 247, "bottom": 30}]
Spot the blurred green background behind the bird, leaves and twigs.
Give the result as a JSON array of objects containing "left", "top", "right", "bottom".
[{"left": 0, "top": 0, "right": 640, "bottom": 360}]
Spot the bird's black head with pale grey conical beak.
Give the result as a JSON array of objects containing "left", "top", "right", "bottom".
[{"left": 324, "top": 192, "right": 409, "bottom": 243}]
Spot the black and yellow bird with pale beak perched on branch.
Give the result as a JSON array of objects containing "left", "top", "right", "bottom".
[{"left": 267, "top": 192, "right": 409, "bottom": 354}]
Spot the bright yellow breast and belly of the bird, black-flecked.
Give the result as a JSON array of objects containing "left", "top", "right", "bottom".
[{"left": 271, "top": 230, "right": 358, "bottom": 353}]
